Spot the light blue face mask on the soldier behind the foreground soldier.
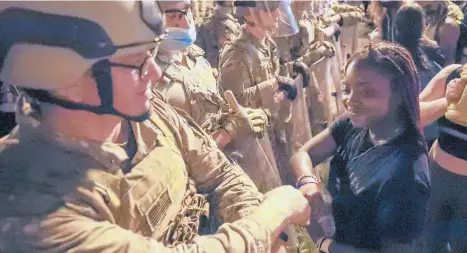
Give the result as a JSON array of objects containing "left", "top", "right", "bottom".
[{"left": 160, "top": 25, "right": 196, "bottom": 52}]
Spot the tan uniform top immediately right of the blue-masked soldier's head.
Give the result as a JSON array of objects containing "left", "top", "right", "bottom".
[{"left": 195, "top": 7, "right": 240, "bottom": 68}]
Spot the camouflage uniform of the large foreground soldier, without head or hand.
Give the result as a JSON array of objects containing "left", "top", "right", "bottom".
[{"left": 0, "top": 95, "right": 270, "bottom": 253}]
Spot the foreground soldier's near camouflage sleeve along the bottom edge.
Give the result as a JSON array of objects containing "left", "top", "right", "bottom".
[{"left": 0, "top": 191, "right": 271, "bottom": 253}]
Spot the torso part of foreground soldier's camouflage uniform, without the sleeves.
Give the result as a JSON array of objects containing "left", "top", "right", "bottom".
[{"left": 0, "top": 98, "right": 206, "bottom": 244}]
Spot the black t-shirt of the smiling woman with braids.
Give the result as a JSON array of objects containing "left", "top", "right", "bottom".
[{"left": 328, "top": 116, "right": 429, "bottom": 250}]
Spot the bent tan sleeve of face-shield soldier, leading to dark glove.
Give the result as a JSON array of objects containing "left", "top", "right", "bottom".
[{"left": 217, "top": 50, "right": 273, "bottom": 107}]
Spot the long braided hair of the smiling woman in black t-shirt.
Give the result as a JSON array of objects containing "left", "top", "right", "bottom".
[{"left": 344, "top": 41, "right": 424, "bottom": 150}]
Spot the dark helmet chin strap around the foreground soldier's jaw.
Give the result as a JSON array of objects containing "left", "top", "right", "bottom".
[{"left": 31, "top": 60, "right": 151, "bottom": 122}]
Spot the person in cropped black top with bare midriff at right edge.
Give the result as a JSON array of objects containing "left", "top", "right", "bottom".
[{"left": 420, "top": 64, "right": 467, "bottom": 253}]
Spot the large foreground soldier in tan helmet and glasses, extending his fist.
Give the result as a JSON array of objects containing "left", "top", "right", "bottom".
[{"left": 0, "top": 1, "right": 309, "bottom": 253}]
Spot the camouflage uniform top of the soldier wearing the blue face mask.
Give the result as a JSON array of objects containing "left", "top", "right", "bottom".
[{"left": 155, "top": 45, "right": 229, "bottom": 133}]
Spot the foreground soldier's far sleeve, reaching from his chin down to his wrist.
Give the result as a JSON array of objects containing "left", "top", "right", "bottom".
[{"left": 153, "top": 94, "right": 263, "bottom": 222}]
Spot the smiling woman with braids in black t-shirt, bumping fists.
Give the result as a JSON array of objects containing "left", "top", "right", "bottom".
[{"left": 291, "top": 42, "right": 430, "bottom": 253}]
